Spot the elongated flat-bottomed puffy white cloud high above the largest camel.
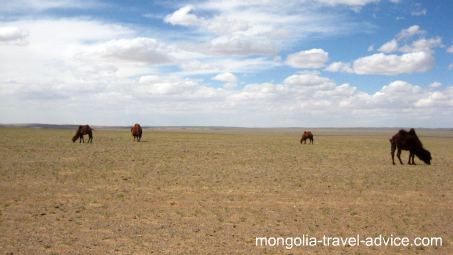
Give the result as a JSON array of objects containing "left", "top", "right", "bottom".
[{"left": 353, "top": 52, "right": 434, "bottom": 75}]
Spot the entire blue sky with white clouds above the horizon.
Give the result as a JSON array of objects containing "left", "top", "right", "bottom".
[{"left": 0, "top": 0, "right": 453, "bottom": 127}]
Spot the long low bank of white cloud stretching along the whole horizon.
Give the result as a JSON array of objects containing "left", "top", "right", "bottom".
[{"left": 0, "top": 63, "right": 453, "bottom": 126}]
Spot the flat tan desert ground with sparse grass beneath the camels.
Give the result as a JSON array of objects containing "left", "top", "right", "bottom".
[{"left": 0, "top": 127, "right": 453, "bottom": 254}]
